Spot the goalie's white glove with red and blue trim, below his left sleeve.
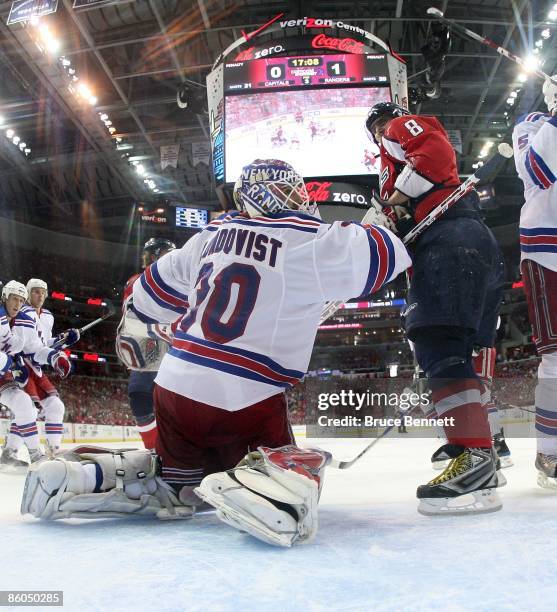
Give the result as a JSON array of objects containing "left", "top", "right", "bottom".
[{"left": 116, "top": 296, "right": 172, "bottom": 372}]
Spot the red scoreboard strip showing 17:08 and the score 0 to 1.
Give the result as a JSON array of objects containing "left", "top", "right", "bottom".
[{"left": 224, "top": 53, "right": 389, "bottom": 95}]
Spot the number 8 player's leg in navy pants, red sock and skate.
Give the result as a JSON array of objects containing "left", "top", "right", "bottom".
[{"left": 406, "top": 217, "right": 504, "bottom": 514}]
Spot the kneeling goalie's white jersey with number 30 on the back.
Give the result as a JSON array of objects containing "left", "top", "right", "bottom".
[{"left": 133, "top": 211, "right": 411, "bottom": 411}]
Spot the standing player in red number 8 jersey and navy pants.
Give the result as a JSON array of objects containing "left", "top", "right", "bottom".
[{"left": 366, "top": 102, "right": 504, "bottom": 514}]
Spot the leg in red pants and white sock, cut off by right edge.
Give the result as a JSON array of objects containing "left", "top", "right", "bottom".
[{"left": 520, "top": 259, "right": 557, "bottom": 489}]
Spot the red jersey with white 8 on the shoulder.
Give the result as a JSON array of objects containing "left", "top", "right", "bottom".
[{"left": 379, "top": 115, "right": 460, "bottom": 223}]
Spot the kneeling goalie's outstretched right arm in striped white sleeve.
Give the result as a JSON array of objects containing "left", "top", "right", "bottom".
[{"left": 314, "top": 221, "right": 411, "bottom": 302}]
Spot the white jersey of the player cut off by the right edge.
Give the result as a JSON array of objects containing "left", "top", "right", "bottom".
[{"left": 513, "top": 113, "right": 557, "bottom": 271}]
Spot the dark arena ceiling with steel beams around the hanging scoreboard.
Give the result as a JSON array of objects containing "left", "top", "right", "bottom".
[{"left": 0, "top": 0, "right": 557, "bottom": 239}]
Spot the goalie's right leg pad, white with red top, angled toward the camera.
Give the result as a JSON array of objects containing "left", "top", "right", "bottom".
[{"left": 195, "top": 446, "right": 331, "bottom": 547}]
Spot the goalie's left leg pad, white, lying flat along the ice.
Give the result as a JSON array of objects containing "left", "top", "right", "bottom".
[{"left": 21, "top": 449, "right": 194, "bottom": 520}]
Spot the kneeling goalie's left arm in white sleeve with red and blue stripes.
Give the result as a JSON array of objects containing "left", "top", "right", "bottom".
[{"left": 129, "top": 237, "right": 192, "bottom": 324}]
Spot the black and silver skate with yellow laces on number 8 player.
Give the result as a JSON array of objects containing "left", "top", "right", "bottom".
[{"left": 417, "top": 444, "right": 503, "bottom": 516}]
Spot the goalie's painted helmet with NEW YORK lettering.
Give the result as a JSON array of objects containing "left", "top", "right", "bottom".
[{"left": 233, "top": 159, "right": 317, "bottom": 217}]
